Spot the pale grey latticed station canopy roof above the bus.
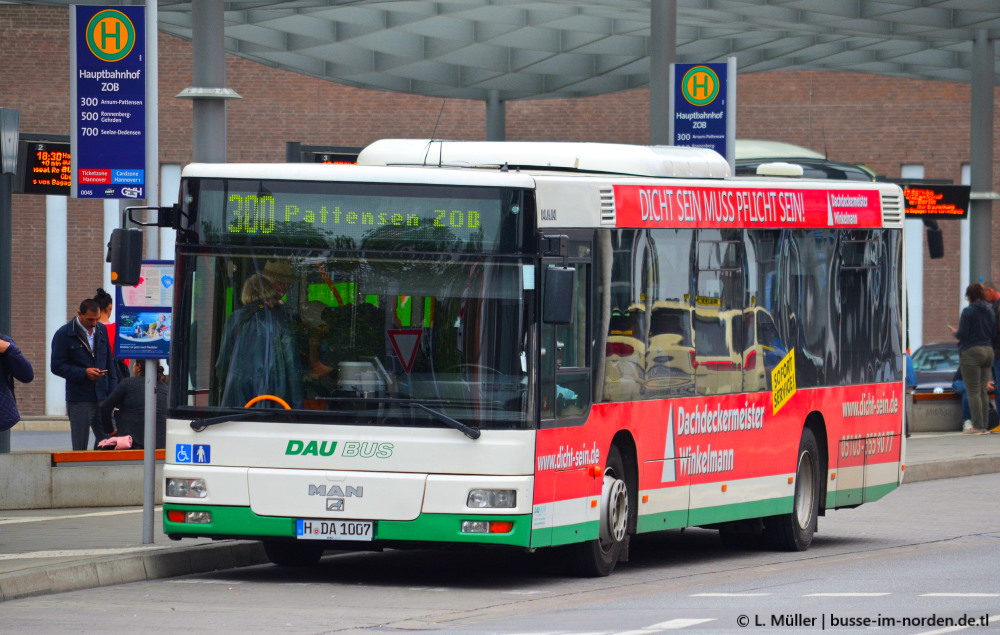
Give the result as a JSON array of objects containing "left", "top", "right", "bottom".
[{"left": 34, "top": 0, "right": 1000, "bottom": 100}]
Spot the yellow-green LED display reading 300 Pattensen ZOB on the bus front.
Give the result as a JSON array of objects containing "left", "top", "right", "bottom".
[{"left": 198, "top": 181, "right": 508, "bottom": 251}]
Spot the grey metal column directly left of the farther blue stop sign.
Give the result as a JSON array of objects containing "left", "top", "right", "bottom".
[{"left": 649, "top": 0, "right": 677, "bottom": 145}]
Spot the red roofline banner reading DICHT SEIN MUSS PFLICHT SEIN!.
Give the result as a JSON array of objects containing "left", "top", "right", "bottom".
[{"left": 614, "top": 185, "right": 882, "bottom": 229}]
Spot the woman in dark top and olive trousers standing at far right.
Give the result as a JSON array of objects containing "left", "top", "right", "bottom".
[{"left": 948, "top": 282, "right": 997, "bottom": 434}]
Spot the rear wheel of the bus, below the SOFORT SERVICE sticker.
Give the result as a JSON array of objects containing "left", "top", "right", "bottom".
[{"left": 764, "top": 428, "right": 820, "bottom": 551}]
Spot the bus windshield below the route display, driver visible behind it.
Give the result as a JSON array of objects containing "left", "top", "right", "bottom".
[{"left": 177, "top": 253, "right": 529, "bottom": 428}]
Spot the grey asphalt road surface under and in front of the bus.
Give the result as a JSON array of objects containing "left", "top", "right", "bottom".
[{"left": 2, "top": 474, "right": 1000, "bottom": 634}]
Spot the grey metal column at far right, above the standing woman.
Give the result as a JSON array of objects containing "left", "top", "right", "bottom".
[{"left": 969, "top": 30, "right": 998, "bottom": 282}]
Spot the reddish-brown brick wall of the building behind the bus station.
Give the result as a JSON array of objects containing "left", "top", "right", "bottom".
[{"left": 0, "top": 5, "right": 1000, "bottom": 415}]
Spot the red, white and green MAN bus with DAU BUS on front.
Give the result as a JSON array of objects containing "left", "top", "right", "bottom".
[{"left": 163, "top": 140, "right": 905, "bottom": 575}]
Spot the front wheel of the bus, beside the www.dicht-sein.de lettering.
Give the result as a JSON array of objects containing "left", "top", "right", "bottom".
[{"left": 573, "top": 446, "right": 629, "bottom": 577}]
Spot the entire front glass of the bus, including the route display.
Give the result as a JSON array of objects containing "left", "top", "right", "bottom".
[{"left": 172, "top": 179, "right": 534, "bottom": 428}]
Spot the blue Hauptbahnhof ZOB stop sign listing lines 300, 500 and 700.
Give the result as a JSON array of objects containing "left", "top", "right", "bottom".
[{"left": 70, "top": 5, "right": 146, "bottom": 199}]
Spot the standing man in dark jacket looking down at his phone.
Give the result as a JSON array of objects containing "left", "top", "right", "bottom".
[{"left": 50, "top": 299, "right": 118, "bottom": 450}]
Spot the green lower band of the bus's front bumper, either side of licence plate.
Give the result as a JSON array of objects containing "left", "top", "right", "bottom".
[{"left": 163, "top": 504, "right": 531, "bottom": 547}]
